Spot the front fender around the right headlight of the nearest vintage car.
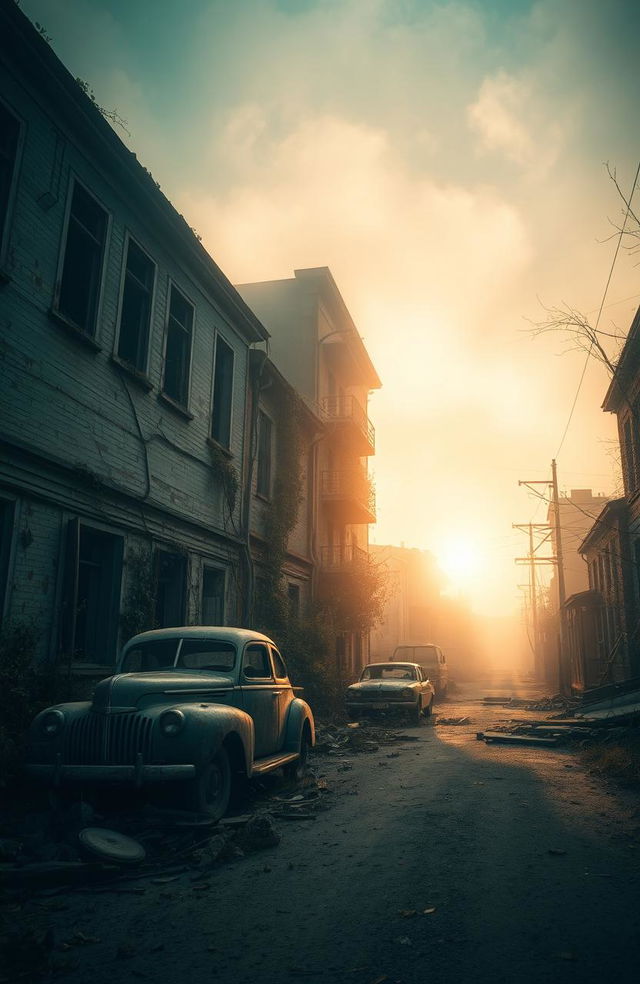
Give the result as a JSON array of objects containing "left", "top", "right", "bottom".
[{"left": 145, "top": 702, "right": 255, "bottom": 776}]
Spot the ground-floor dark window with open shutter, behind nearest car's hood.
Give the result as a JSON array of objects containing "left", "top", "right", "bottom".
[{"left": 62, "top": 520, "right": 123, "bottom": 666}]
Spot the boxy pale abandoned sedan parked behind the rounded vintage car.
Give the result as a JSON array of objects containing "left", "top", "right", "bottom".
[{"left": 345, "top": 663, "right": 435, "bottom": 724}]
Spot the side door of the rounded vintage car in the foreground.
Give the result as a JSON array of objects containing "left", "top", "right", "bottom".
[{"left": 240, "top": 642, "right": 279, "bottom": 758}]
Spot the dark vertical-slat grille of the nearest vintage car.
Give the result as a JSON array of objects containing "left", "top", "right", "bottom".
[{"left": 64, "top": 714, "right": 151, "bottom": 765}]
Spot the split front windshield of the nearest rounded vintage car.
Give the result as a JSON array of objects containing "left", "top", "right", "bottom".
[{"left": 120, "top": 638, "right": 236, "bottom": 673}]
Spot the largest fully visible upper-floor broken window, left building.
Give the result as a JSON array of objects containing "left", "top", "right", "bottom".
[{"left": 58, "top": 181, "right": 107, "bottom": 335}]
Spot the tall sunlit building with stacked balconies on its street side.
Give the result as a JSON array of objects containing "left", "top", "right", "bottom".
[{"left": 238, "top": 267, "right": 381, "bottom": 677}]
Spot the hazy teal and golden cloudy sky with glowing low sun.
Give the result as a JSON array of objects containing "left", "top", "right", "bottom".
[{"left": 21, "top": 0, "right": 640, "bottom": 612}]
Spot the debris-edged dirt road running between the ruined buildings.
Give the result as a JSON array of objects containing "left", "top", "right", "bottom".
[{"left": 10, "top": 684, "right": 640, "bottom": 984}]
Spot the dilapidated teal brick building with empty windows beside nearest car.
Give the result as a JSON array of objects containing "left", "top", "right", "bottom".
[{"left": 0, "top": 3, "right": 267, "bottom": 675}]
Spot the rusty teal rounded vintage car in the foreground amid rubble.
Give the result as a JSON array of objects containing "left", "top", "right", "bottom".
[{"left": 26, "top": 626, "right": 315, "bottom": 818}]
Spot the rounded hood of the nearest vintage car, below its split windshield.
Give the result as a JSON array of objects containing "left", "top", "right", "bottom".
[{"left": 93, "top": 670, "right": 233, "bottom": 711}]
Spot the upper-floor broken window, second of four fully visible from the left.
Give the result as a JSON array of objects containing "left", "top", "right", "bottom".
[{"left": 118, "top": 239, "right": 156, "bottom": 372}]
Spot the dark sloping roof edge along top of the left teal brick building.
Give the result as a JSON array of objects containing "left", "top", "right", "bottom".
[{"left": 0, "top": 0, "right": 269, "bottom": 343}]
